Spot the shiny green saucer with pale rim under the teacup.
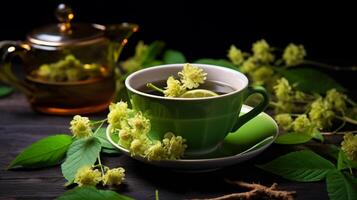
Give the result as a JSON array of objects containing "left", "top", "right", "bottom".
[{"left": 107, "top": 105, "right": 278, "bottom": 170}]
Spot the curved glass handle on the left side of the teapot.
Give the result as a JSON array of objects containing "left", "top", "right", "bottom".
[{"left": 0, "top": 41, "right": 32, "bottom": 96}]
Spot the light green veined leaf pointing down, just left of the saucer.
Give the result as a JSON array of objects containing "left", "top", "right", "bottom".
[{"left": 61, "top": 137, "right": 101, "bottom": 183}]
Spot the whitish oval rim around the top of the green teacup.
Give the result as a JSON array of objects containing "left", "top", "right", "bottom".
[{"left": 125, "top": 63, "right": 249, "bottom": 101}]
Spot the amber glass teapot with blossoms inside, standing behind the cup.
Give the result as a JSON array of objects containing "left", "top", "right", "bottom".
[{"left": 0, "top": 4, "right": 138, "bottom": 115}]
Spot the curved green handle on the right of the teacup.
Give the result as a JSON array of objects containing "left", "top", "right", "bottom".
[{"left": 232, "top": 86, "right": 269, "bottom": 132}]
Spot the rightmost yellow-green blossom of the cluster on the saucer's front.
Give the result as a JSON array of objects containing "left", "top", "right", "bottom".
[{"left": 162, "top": 132, "right": 187, "bottom": 159}]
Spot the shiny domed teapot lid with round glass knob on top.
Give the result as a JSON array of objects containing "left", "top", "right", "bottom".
[{"left": 27, "top": 4, "right": 105, "bottom": 47}]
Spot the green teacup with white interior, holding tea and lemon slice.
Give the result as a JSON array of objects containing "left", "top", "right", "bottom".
[{"left": 125, "top": 64, "right": 269, "bottom": 156}]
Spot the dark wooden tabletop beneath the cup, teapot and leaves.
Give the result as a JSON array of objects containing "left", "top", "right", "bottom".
[{"left": 0, "top": 93, "right": 328, "bottom": 200}]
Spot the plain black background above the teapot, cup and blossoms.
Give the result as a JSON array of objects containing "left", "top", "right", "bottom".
[{"left": 0, "top": 0, "right": 357, "bottom": 85}]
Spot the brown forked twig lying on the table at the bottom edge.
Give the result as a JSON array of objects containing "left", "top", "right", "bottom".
[{"left": 191, "top": 179, "right": 296, "bottom": 200}]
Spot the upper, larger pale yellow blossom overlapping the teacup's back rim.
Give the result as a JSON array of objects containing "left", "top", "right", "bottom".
[{"left": 178, "top": 63, "right": 207, "bottom": 89}]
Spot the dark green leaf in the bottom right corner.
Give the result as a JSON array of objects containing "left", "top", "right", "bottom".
[{"left": 326, "top": 170, "right": 357, "bottom": 200}]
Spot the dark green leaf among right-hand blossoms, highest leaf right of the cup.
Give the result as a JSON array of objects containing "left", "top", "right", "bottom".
[{"left": 274, "top": 68, "right": 345, "bottom": 94}]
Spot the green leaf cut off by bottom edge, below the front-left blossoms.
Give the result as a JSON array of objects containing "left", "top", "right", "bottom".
[{"left": 57, "top": 186, "right": 133, "bottom": 200}]
